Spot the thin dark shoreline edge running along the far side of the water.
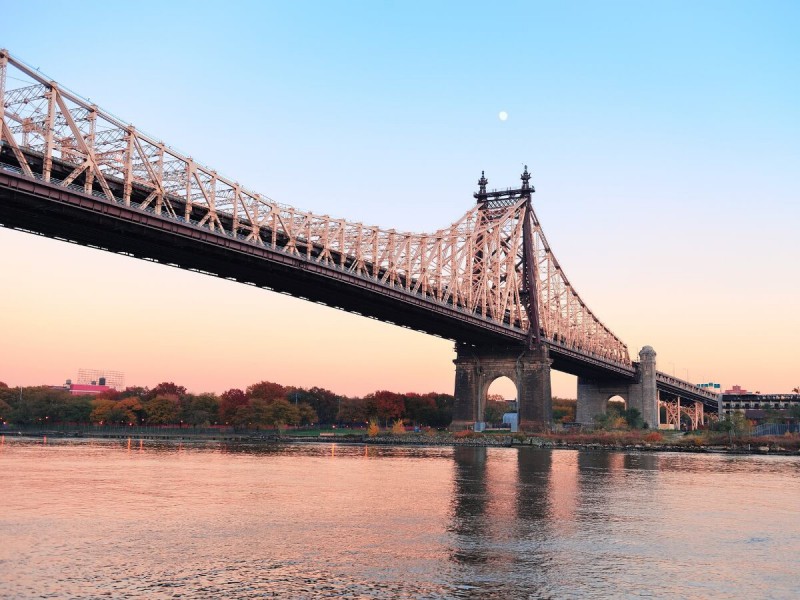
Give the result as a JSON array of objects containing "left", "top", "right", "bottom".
[{"left": 0, "top": 430, "right": 800, "bottom": 456}]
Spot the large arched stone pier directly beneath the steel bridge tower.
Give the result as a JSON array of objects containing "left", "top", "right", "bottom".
[{"left": 450, "top": 344, "right": 553, "bottom": 431}]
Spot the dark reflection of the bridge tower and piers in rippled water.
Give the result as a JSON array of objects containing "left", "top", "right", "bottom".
[{"left": 450, "top": 447, "right": 660, "bottom": 597}]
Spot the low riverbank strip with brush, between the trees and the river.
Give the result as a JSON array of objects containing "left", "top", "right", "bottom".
[{"left": 2, "top": 429, "right": 800, "bottom": 456}]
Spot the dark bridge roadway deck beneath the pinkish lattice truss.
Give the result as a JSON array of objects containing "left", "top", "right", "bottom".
[{"left": 0, "top": 164, "right": 635, "bottom": 379}]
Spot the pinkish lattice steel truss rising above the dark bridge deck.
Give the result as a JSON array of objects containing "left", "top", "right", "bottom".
[{"left": 0, "top": 50, "right": 631, "bottom": 368}]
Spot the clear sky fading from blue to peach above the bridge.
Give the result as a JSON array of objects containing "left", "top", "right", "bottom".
[{"left": 0, "top": 0, "right": 800, "bottom": 394}]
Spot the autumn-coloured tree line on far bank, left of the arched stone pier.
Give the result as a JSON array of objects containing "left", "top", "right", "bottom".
[{"left": 0, "top": 381, "right": 453, "bottom": 429}]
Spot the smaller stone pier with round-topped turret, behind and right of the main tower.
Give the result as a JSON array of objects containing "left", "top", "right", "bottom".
[{"left": 576, "top": 346, "right": 659, "bottom": 429}]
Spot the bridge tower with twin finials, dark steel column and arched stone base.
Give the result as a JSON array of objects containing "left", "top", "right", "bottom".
[{"left": 450, "top": 165, "right": 553, "bottom": 431}]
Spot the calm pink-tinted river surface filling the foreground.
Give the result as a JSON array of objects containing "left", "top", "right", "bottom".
[{"left": 0, "top": 436, "right": 800, "bottom": 598}]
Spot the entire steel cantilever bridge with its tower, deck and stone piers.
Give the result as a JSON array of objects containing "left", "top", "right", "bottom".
[{"left": 0, "top": 50, "right": 716, "bottom": 426}]
